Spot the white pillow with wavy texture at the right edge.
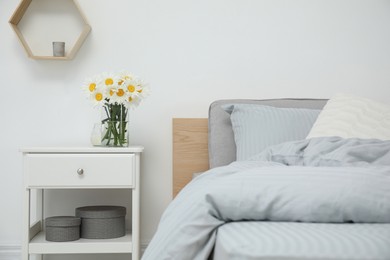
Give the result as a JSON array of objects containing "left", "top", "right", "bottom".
[{"left": 306, "top": 94, "right": 390, "bottom": 140}]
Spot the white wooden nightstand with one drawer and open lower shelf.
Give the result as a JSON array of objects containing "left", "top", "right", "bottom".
[{"left": 21, "top": 146, "right": 143, "bottom": 260}]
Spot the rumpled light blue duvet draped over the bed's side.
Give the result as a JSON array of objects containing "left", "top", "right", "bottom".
[{"left": 143, "top": 137, "right": 390, "bottom": 260}]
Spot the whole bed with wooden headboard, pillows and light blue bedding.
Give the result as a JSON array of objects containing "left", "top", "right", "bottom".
[{"left": 143, "top": 95, "right": 390, "bottom": 260}]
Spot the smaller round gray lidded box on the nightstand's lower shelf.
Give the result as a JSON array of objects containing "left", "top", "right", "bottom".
[{"left": 45, "top": 216, "right": 81, "bottom": 242}]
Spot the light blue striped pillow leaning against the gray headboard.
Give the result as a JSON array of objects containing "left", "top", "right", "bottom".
[{"left": 222, "top": 104, "right": 321, "bottom": 161}]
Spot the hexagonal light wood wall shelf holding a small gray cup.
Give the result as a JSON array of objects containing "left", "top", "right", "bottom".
[{"left": 9, "top": 0, "right": 91, "bottom": 60}]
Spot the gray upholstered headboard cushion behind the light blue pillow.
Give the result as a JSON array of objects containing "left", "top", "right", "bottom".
[{"left": 208, "top": 99, "right": 328, "bottom": 168}]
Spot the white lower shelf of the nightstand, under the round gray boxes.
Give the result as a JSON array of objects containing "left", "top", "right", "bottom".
[{"left": 28, "top": 231, "right": 133, "bottom": 254}]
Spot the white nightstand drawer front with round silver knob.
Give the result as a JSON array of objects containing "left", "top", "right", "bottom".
[{"left": 25, "top": 153, "right": 135, "bottom": 188}]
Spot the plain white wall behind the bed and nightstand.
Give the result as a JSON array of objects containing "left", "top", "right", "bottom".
[{"left": 0, "top": 0, "right": 390, "bottom": 258}]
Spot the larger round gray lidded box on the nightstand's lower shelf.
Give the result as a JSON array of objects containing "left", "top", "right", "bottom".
[{"left": 76, "top": 206, "right": 126, "bottom": 239}]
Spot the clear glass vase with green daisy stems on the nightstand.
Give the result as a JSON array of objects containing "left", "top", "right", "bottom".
[{"left": 101, "top": 104, "right": 129, "bottom": 147}]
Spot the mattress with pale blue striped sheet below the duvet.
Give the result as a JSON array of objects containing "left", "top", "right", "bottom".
[{"left": 213, "top": 221, "right": 390, "bottom": 260}]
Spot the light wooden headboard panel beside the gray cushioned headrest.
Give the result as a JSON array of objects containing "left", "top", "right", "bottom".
[{"left": 172, "top": 118, "right": 209, "bottom": 197}]
